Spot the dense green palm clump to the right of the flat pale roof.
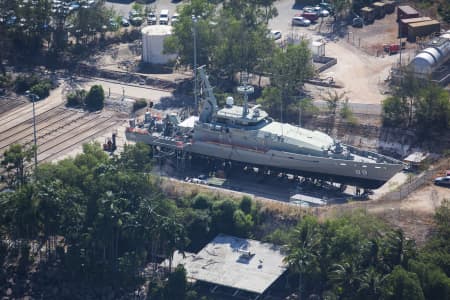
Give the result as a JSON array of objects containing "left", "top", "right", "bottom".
[{"left": 285, "top": 211, "right": 450, "bottom": 299}]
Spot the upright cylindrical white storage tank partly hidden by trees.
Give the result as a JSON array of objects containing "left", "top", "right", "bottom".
[{"left": 141, "top": 25, "right": 177, "bottom": 64}]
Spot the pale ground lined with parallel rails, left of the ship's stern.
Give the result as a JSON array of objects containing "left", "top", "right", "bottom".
[{"left": 0, "top": 85, "right": 120, "bottom": 163}]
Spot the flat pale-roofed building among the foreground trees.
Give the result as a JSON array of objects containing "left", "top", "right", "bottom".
[{"left": 162, "top": 234, "right": 287, "bottom": 298}]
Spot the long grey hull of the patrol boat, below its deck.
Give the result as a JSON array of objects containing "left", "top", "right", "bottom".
[{"left": 127, "top": 133, "right": 403, "bottom": 188}]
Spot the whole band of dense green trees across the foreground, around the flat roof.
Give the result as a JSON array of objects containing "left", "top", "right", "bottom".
[{"left": 0, "top": 144, "right": 450, "bottom": 300}]
